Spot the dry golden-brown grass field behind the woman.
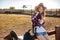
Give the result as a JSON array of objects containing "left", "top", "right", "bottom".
[{"left": 0, "top": 14, "right": 60, "bottom": 40}]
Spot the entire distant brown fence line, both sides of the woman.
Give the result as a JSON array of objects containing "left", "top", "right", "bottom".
[{"left": 0, "top": 9, "right": 60, "bottom": 16}]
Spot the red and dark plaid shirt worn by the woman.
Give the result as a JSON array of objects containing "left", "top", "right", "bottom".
[{"left": 31, "top": 12, "right": 42, "bottom": 27}]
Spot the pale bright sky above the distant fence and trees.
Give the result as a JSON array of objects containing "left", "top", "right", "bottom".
[{"left": 0, "top": 0, "right": 60, "bottom": 9}]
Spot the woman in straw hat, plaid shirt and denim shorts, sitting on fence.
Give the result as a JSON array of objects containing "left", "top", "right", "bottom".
[{"left": 32, "top": 3, "right": 49, "bottom": 40}]
